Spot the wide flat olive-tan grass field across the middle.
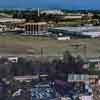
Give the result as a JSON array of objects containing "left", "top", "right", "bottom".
[{"left": 0, "top": 35, "right": 100, "bottom": 57}]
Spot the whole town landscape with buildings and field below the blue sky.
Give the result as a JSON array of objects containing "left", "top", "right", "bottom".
[{"left": 0, "top": 8, "right": 100, "bottom": 100}]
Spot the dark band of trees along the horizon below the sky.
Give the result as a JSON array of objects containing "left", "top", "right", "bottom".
[{"left": 0, "top": 9, "right": 100, "bottom": 26}]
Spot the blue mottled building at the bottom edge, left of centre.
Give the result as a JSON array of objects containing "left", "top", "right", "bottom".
[{"left": 31, "top": 82, "right": 60, "bottom": 100}]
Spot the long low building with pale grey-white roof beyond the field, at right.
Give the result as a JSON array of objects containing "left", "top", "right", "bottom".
[{"left": 48, "top": 25, "right": 100, "bottom": 38}]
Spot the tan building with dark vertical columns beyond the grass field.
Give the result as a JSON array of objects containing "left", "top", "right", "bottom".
[{"left": 24, "top": 22, "right": 48, "bottom": 35}]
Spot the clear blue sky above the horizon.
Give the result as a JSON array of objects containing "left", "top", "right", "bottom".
[{"left": 0, "top": 0, "right": 100, "bottom": 9}]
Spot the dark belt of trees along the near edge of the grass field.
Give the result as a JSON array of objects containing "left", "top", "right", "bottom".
[{"left": 0, "top": 51, "right": 84, "bottom": 78}]
